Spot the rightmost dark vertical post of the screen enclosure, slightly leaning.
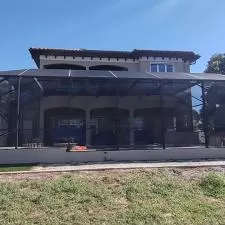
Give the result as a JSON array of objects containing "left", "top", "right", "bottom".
[{"left": 201, "top": 81, "right": 209, "bottom": 148}]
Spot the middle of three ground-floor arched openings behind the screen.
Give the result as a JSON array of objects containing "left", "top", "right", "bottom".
[{"left": 91, "top": 108, "right": 130, "bottom": 146}]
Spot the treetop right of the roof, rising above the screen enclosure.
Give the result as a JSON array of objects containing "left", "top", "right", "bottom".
[{"left": 205, "top": 53, "right": 225, "bottom": 74}]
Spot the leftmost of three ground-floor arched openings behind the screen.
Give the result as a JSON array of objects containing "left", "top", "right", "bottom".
[{"left": 44, "top": 107, "right": 86, "bottom": 146}]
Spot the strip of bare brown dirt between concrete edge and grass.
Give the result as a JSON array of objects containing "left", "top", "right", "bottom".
[{"left": 0, "top": 166, "right": 225, "bottom": 183}]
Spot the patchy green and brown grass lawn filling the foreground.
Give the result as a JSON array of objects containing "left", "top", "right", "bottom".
[{"left": 0, "top": 169, "right": 225, "bottom": 225}]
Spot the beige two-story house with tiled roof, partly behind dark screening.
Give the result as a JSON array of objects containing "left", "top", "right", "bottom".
[{"left": 24, "top": 48, "right": 199, "bottom": 146}]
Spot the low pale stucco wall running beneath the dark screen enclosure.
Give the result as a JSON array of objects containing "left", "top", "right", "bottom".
[{"left": 0, "top": 148, "right": 225, "bottom": 164}]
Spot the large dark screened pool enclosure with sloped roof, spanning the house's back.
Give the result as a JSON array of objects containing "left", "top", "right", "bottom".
[{"left": 0, "top": 69, "right": 225, "bottom": 150}]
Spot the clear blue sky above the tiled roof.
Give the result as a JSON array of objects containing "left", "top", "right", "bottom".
[{"left": 0, "top": 0, "right": 225, "bottom": 72}]
